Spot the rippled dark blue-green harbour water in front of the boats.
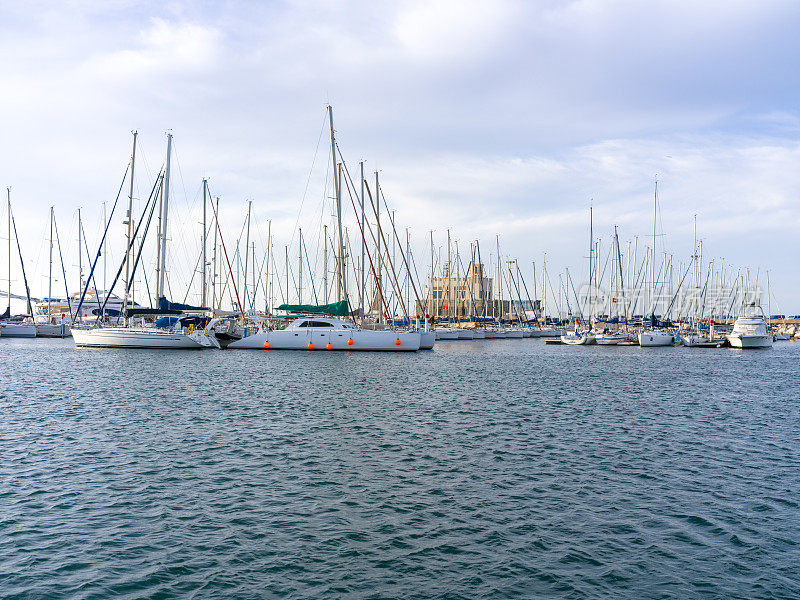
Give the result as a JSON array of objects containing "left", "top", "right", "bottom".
[{"left": 0, "top": 339, "right": 800, "bottom": 599}]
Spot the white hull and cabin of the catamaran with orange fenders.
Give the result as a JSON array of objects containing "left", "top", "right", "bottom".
[{"left": 228, "top": 316, "right": 422, "bottom": 352}]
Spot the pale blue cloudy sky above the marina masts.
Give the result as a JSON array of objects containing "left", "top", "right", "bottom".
[{"left": 0, "top": 0, "right": 800, "bottom": 314}]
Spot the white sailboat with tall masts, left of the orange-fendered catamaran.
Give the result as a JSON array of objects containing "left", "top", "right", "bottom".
[{"left": 71, "top": 132, "right": 205, "bottom": 349}]
